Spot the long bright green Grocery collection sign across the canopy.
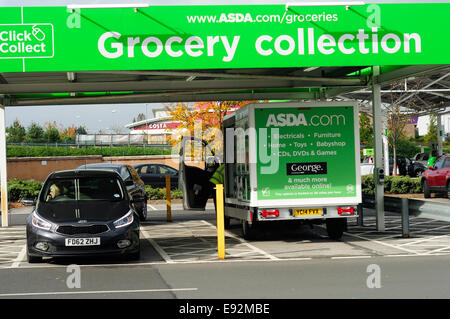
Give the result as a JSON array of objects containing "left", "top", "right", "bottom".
[{"left": 0, "top": 3, "right": 450, "bottom": 72}]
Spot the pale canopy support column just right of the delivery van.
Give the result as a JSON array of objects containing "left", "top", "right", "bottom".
[{"left": 372, "top": 66, "right": 389, "bottom": 231}]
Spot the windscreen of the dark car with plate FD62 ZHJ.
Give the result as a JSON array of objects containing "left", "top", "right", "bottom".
[{"left": 40, "top": 176, "right": 125, "bottom": 203}]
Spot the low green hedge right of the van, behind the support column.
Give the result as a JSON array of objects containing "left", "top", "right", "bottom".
[{"left": 361, "top": 175, "right": 423, "bottom": 195}]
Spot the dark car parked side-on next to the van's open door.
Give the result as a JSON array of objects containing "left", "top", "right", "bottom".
[{"left": 133, "top": 163, "right": 178, "bottom": 189}]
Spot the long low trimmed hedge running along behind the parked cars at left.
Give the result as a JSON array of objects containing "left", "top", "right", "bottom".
[{"left": 6, "top": 145, "right": 171, "bottom": 157}]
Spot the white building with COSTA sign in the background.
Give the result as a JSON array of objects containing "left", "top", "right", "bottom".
[{"left": 125, "top": 109, "right": 180, "bottom": 144}]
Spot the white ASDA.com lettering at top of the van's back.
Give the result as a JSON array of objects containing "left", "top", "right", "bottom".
[{"left": 266, "top": 113, "right": 345, "bottom": 127}]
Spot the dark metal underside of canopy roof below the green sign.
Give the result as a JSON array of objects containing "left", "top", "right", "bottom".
[{"left": 0, "top": 65, "right": 450, "bottom": 115}]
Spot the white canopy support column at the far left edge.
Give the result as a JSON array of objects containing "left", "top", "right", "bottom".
[{"left": 0, "top": 105, "right": 9, "bottom": 227}]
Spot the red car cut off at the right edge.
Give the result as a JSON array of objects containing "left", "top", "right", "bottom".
[{"left": 422, "top": 155, "right": 450, "bottom": 199}]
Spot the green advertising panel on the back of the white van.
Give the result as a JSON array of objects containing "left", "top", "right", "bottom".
[{"left": 255, "top": 106, "right": 357, "bottom": 200}]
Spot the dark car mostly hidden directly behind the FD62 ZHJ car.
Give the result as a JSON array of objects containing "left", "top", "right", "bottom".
[{"left": 77, "top": 163, "right": 147, "bottom": 221}]
